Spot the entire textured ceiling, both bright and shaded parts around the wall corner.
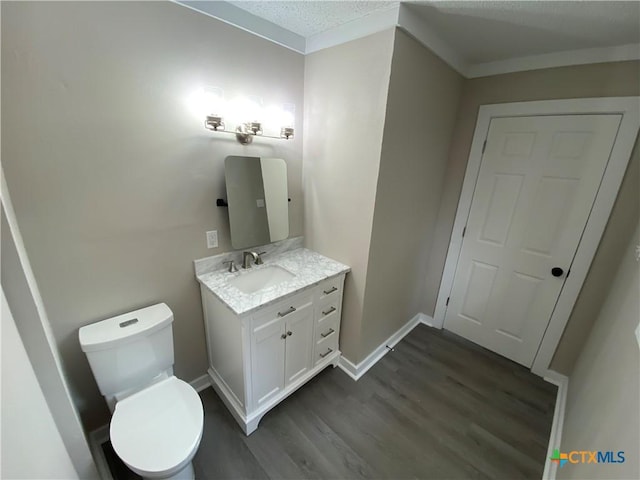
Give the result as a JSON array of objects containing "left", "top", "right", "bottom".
[{"left": 222, "top": 0, "right": 640, "bottom": 64}]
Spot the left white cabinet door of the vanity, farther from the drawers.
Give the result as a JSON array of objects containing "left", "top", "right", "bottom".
[{"left": 251, "top": 318, "right": 285, "bottom": 408}]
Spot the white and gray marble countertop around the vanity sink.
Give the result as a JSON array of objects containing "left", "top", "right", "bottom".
[{"left": 196, "top": 248, "right": 351, "bottom": 315}]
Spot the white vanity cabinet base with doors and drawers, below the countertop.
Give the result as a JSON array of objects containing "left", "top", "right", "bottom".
[{"left": 201, "top": 273, "right": 345, "bottom": 435}]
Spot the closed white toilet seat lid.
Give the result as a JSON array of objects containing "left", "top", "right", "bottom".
[{"left": 109, "top": 377, "right": 204, "bottom": 472}]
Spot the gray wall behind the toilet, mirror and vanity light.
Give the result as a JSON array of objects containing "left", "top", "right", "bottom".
[{"left": 2, "top": 2, "right": 304, "bottom": 429}]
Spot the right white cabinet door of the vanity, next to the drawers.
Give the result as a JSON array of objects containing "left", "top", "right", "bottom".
[{"left": 284, "top": 306, "right": 313, "bottom": 385}]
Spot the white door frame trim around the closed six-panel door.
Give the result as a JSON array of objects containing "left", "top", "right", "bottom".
[{"left": 433, "top": 97, "right": 640, "bottom": 376}]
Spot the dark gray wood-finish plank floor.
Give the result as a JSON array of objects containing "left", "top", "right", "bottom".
[{"left": 105, "top": 325, "right": 556, "bottom": 479}]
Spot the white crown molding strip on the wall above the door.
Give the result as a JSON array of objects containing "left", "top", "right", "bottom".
[{"left": 466, "top": 43, "right": 640, "bottom": 78}]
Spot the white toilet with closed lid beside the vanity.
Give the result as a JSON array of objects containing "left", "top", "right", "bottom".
[{"left": 79, "top": 303, "right": 204, "bottom": 479}]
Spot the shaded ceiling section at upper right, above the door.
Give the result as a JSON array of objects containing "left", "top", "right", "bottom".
[{"left": 406, "top": 1, "right": 640, "bottom": 63}]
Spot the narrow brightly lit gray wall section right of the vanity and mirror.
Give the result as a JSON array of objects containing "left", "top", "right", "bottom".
[{"left": 304, "top": 29, "right": 394, "bottom": 362}]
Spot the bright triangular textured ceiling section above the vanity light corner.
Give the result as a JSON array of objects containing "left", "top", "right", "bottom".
[{"left": 229, "top": 0, "right": 400, "bottom": 37}]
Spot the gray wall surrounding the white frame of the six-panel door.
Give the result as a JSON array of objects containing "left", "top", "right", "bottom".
[{"left": 424, "top": 61, "right": 640, "bottom": 374}]
